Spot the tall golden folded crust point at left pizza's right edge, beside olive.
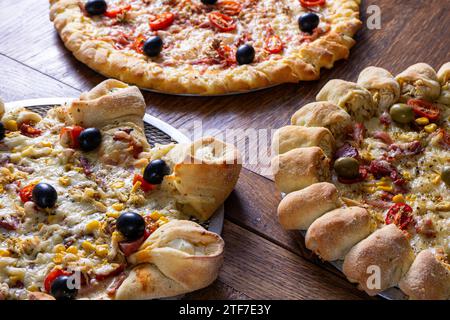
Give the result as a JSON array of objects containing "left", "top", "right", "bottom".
[{"left": 164, "top": 137, "right": 242, "bottom": 221}]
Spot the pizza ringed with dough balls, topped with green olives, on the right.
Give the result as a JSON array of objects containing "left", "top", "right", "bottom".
[{"left": 272, "top": 63, "right": 450, "bottom": 299}]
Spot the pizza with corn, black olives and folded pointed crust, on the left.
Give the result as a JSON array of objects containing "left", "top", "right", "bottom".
[{"left": 0, "top": 80, "right": 241, "bottom": 300}]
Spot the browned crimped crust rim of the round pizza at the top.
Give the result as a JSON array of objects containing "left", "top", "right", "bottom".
[{"left": 50, "top": 0, "right": 361, "bottom": 95}]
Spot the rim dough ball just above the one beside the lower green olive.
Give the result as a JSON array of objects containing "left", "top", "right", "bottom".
[{"left": 272, "top": 126, "right": 335, "bottom": 158}]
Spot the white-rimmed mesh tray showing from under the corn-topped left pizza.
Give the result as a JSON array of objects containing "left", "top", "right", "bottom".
[{"left": 6, "top": 98, "right": 224, "bottom": 234}]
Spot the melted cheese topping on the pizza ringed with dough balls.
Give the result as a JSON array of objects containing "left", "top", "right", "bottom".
[{"left": 333, "top": 105, "right": 450, "bottom": 255}]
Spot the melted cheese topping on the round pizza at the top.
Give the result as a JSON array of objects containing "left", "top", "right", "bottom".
[{"left": 81, "top": 0, "right": 342, "bottom": 71}]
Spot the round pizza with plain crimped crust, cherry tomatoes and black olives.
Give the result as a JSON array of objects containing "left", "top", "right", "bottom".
[{"left": 50, "top": 0, "right": 361, "bottom": 95}]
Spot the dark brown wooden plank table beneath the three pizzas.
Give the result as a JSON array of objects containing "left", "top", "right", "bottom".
[{"left": 0, "top": 0, "right": 450, "bottom": 299}]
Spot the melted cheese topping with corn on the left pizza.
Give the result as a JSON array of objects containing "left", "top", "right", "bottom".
[{"left": 0, "top": 109, "right": 192, "bottom": 299}]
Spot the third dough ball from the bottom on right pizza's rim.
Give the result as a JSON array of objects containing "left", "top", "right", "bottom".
[{"left": 305, "top": 207, "right": 372, "bottom": 261}]
